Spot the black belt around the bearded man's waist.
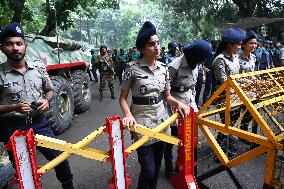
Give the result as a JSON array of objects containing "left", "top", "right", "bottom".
[{"left": 0, "top": 114, "right": 44, "bottom": 124}]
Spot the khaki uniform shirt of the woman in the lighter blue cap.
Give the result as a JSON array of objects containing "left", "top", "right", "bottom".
[{"left": 213, "top": 52, "right": 240, "bottom": 88}]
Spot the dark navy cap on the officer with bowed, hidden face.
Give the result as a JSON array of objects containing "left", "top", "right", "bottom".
[{"left": 183, "top": 40, "right": 212, "bottom": 64}]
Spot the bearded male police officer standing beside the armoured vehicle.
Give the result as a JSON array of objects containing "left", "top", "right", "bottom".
[{"left": 0, "top": 23, "right": 74, "bottom": 189}]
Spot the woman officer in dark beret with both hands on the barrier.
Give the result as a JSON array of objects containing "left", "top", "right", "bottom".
[{"left": 119, "top": 21, "right": 189, "bottom": 189}]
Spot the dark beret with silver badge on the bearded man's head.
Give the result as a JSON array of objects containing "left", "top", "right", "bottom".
[{"left": 0, "top": 22, "right": 25, "bottom": 43}]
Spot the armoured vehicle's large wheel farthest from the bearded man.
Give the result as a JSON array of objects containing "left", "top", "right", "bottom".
[{"left": 72, "top": 70, "right": 91, "bottom": 113}]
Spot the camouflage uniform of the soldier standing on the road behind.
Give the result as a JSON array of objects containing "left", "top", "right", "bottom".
[{"left": 97, "top": 54, "right": 115, "bottom": 100}]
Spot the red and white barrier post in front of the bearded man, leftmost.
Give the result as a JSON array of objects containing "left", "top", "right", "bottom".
[{"left": 5, "top": 129, "right": 42, "bottom": 189}]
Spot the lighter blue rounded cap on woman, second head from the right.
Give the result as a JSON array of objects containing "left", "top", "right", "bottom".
[{"left": 222, "top": 28, "right": 246, "bottom": 43}]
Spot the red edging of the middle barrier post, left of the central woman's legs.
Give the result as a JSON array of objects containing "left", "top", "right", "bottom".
[{"left": 106, "top": 116, "right": 132, "bottom": 189}]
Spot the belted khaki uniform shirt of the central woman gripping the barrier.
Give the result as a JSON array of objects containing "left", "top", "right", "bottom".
[{"left": 121, "top": 58, "right": 170, "bottom": 145}]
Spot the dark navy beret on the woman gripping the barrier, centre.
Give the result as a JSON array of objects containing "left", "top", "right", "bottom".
[{"left": 136, "top": 21, "right": 156, "bottom": 49}]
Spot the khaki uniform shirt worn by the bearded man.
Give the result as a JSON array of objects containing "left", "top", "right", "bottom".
[{"left": 0, "top": 60, "right": 53, "bottom": 117}]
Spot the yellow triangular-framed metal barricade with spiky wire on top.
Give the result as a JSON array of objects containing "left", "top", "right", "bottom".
[{"left": 196, "top": 67, "right": 284, "bottom": 186}]
